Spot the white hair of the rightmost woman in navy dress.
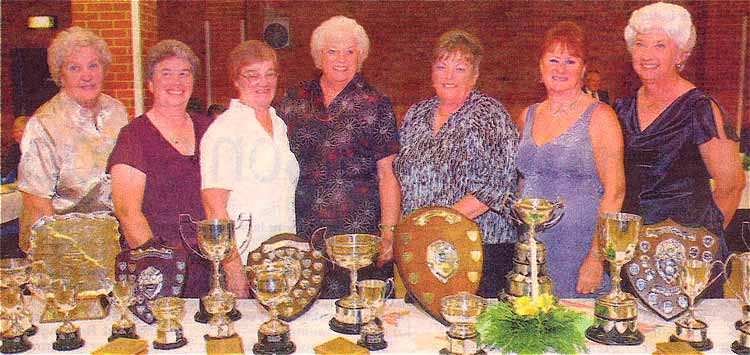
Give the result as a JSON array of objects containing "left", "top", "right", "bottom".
[{"left": 625, "top": 2, "right": 697, "bottom": 53}]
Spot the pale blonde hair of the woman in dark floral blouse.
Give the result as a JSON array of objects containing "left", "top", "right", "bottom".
[{"left": 310, "top": 16, "right": 370, "bottom": 71}]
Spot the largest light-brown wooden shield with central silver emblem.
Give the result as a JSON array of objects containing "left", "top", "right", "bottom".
[{"left": 394, "top": 207, "right": 483, "bottom": 325}]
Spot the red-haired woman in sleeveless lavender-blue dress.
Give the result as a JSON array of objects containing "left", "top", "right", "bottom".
[{"left": 518, "top": 22, "right": 625, "bottom": 297}]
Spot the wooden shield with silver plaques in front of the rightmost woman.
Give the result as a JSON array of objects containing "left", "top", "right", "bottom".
[{"left": 623, "top": 219, "right": 720, "bottom": 320}]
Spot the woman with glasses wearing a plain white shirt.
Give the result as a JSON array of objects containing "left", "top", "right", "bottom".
[{"left": 201, "top": 40, "right": 299, "bottom": 297}]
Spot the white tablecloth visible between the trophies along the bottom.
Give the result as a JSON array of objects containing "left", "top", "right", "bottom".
[{"left": 11, "top": 299, "right": 740, "bottom": 355}]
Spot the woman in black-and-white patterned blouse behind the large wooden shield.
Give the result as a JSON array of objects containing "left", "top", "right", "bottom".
[{"left": 394, "top": 30, "right": 519, "bottom": 297}]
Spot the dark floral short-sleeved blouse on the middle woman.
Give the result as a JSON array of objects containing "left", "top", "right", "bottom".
[{"left": 277, "top": 74, "right": 399, "bottom": 238}]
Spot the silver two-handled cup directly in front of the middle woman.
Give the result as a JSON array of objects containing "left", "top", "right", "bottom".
[{"left": 311, "top": 234, "right": 380, "bottom": 334}]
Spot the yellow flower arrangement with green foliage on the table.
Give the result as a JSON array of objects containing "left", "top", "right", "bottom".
[{"left": 477, "top": 294, "right": 591, "bottom": 354}]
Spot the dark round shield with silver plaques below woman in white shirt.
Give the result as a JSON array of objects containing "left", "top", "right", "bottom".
[{"left": 247, "top": 233, "right": 326, "bottom": 322}]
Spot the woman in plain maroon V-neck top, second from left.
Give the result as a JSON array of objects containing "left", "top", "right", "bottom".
[{"left": 107, "top": 40, "right": 211, "bottom": 297}]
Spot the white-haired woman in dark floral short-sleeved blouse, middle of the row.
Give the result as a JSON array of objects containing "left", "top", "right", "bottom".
[{"left": 278, "top": 16, "right": 401, "bottom": 298}]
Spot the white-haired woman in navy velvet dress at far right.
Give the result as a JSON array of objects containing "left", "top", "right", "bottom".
[{"left": 615, "top": 3, "right": 744, "bottom": 296}]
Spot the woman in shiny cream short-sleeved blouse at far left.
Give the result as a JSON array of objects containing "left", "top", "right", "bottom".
[{"left": 18, "top": 27, "right": 128, "bottom": 250}]
